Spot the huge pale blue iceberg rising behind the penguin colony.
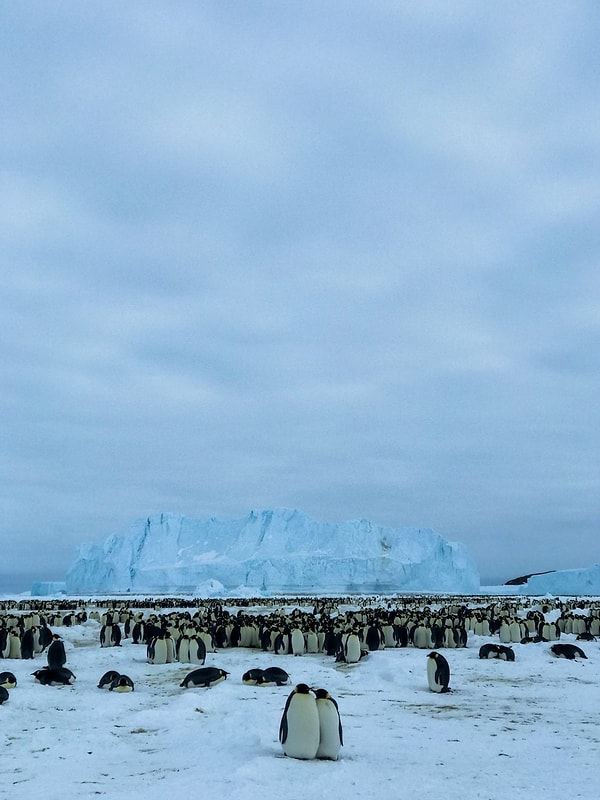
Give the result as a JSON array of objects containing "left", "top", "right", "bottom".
[{"left": 66, "top": 509, "right": 479, "bottom": 595}]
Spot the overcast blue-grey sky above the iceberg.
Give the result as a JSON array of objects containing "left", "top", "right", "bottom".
[{"left": 0, "top": 0, "right": 600, "bottom": 588}]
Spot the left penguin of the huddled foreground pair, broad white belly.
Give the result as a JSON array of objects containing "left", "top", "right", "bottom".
[{"left": 279, "top": 683, "right": 320, "bottom": 759}]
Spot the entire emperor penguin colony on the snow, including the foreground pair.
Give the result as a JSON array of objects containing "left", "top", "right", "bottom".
[{"left": 0, "top": 596, "right": 600, "bottom": 760}]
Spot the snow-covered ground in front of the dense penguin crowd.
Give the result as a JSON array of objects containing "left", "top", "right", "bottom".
[{"left": 0, "top": 600, "right": 600, "bottom": 800}]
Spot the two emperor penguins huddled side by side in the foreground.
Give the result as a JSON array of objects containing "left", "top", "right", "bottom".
[{"left": 279, "top": 683, "right": 344, "bottom": 761}]
